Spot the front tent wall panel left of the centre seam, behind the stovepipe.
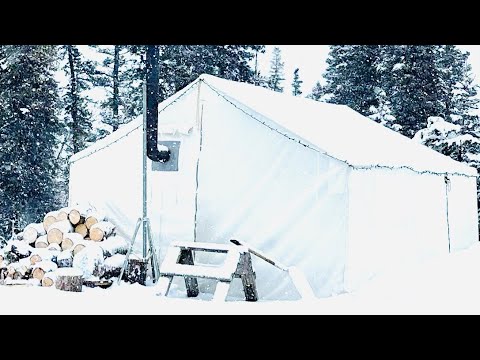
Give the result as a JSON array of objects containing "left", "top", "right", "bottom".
[{"left": 69, "top": 89, "right": 199, "bottom": 261}]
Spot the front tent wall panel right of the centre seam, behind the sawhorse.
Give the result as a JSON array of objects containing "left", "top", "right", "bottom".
[{"left": 197, "top": 85, "right": 348, "bottom": 299}]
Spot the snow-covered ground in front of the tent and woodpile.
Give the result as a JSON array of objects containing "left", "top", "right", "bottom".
[{"left": 0, "top": 245, "right": 480, "bottom": 314}]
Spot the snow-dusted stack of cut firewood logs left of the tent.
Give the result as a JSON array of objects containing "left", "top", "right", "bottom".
[{"left": 0, "top": 206, "right": 128, "bottom": 291}]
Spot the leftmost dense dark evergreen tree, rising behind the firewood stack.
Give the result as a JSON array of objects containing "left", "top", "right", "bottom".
[{"left": 0, "top": 45, "right": 62, "bottom": 242}]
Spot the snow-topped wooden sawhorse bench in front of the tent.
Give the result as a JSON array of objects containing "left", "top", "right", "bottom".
[{"left": 157, "top": 241, "right": 258, "bottom": 301}]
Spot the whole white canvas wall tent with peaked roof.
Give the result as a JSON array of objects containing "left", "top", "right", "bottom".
[{"left": 70, "top": 75, "right": 478, "bottom": 299}]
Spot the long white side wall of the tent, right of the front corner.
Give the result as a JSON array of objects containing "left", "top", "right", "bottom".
[{"left": 345, "top": 170, "right": 478, "bottom": 291}]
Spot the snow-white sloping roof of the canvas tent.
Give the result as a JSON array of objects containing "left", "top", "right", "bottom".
[{"left": 70, "top": 74, "right": 477, "bottom": 176}]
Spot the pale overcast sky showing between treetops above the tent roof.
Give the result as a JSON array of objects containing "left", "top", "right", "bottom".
[{"left": 259, "top": 45, "right": 480, "bottom": 95}]
